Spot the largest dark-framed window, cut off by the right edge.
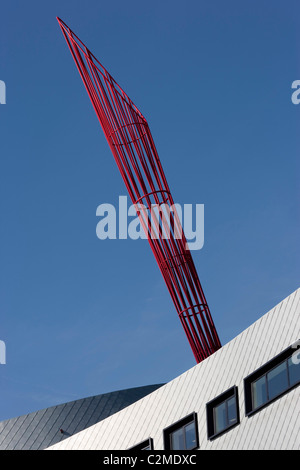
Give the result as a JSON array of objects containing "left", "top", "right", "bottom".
[{"left": 244, "top": 347, "right": 300, "bottom": 416}]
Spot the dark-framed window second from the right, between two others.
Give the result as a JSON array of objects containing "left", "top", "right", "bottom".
[{"left": 206, "top": 386, "right": 240, "bottom": 439}]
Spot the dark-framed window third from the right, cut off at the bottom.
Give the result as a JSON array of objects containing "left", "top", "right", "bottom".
[{"left": 164, "top": 413, "right": 199, "bottom": 450}]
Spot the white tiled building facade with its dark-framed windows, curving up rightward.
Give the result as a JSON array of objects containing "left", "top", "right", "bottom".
[{"left": 48, "top": 289, "right": 300, "bottom": 451}]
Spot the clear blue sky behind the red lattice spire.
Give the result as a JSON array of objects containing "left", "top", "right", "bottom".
[{"left": 0, "top": 0, "right": 300, "bottom": 420}]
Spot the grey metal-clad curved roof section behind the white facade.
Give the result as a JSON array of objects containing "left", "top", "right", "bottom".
[{"left": 0, "top": 384, "right": 163, "bottom": 450}]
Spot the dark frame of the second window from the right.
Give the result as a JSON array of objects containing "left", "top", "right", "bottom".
[{"left": 206, "top": 385, "right": 240, "bottom": 441}]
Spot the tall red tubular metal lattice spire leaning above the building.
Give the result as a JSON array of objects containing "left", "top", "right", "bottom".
[{"left": 57, "top": 18, "right": 221, "bottom": 363}]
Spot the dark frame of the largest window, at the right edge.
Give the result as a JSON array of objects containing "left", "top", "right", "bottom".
[{"left": 244, "top": 346, "right": 300, "bottom": 417}]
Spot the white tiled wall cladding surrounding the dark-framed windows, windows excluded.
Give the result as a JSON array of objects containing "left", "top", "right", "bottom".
[{"left": 45, "top": 289, "right": 300, "bottom": 450}]
